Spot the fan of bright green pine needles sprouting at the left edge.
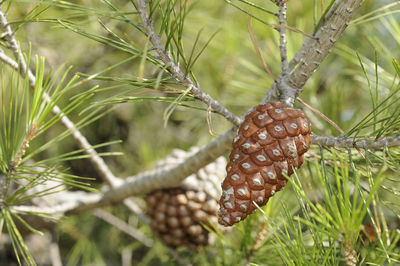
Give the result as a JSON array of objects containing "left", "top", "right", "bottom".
[{"left": 0, "top": 55, "right": 111, "bottom": 265}]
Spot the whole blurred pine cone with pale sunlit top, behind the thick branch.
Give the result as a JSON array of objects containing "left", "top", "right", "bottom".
[{"left": 146, "top": 149, "right": 226, "bottom": 248}]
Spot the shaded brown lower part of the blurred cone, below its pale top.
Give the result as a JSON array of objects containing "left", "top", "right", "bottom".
[{"left": 146, "top": 188, "right": 218, "bottom": 248}]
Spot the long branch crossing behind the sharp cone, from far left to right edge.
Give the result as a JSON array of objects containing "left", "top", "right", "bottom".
[{"left": 11, "top": 130, "right": 400, "bottom": 215}]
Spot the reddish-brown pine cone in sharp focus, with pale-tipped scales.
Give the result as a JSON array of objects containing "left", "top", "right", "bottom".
[{"left": 218, "top": 102, "right": 311, "bottom": 226}]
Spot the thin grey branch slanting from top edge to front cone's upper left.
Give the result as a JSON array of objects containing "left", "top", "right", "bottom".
[{"left": 134, "top": 0, "right": 241, "bottom": 126}]
